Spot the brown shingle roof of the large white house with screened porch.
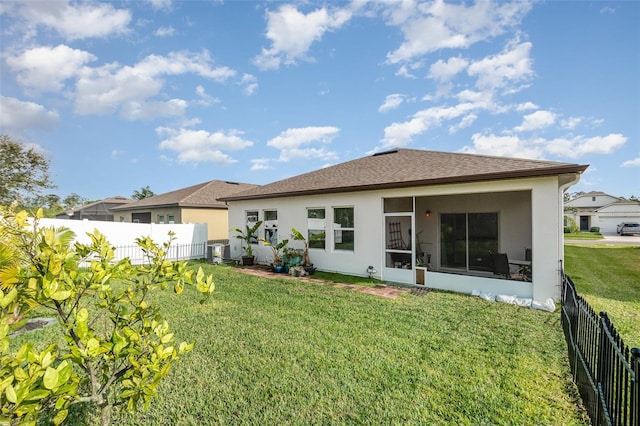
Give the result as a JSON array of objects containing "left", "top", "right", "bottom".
[{"left": 221, "top": 149, "right": 588, "bottom": 201}]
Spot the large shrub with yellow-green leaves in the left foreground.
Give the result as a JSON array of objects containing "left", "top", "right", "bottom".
[{"left": 0, "top": 211, "right": 214, "bottom": 425}]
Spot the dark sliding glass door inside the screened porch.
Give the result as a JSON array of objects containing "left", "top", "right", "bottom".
[{"left": 440, "top": 213, "right": 498, "bottom": 271}]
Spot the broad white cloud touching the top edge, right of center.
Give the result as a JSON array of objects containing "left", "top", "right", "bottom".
[{"left": 387, "top": 1, "right": 531, "bottom": 64}]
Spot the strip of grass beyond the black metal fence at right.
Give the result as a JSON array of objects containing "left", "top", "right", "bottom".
[{"left": 565, "top": 244, "right": 640, "bottom": 347}]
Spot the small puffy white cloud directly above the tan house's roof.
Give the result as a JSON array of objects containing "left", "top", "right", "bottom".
[{"left": 156, "top": 127, "right": 253, "bottom": 164}]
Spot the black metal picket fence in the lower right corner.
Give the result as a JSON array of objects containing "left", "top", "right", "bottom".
[{"left": 562, "top": 274, "right": 640, "bottom": 426}]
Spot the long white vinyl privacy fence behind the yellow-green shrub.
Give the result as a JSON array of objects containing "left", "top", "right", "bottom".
[{"left": 40, "top": 219, "right": 207, "bottom": 265}]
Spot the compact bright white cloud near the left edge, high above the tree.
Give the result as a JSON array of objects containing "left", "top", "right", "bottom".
[{"left": 6, "top": 44, "right": 97, "bottom": 92}]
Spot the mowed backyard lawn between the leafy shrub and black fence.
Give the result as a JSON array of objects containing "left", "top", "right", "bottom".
[{"left": 11, "top": 265, "right": 588, "bottom": 425}]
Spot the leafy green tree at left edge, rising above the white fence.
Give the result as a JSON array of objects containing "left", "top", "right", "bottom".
[{"left": 0, "top": 135, "right": 54, "bottom": 205}]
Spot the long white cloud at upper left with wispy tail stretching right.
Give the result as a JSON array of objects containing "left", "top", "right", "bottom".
[{"left": 75, "top": 52, "right": 235, "bottom": 120}]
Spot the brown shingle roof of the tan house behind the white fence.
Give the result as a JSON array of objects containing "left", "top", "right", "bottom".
[{"left": 112, "top": 180, "right": 256, "bottom": 211}]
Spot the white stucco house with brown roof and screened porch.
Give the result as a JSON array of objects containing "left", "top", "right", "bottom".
[{"left": 223, "top": 149, "right": 588, "bottom": 301}]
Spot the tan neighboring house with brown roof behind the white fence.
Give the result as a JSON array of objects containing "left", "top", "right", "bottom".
[{"left": 113, "top": 180, "right": 256, "bottom": 240}]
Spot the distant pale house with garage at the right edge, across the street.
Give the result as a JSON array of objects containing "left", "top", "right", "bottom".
[{"left": 564, "top": 191, "right": 640, "bottom": 233}]
